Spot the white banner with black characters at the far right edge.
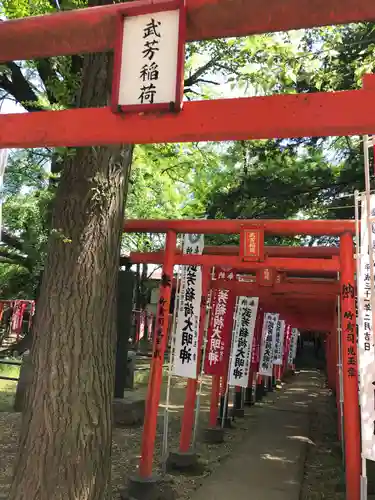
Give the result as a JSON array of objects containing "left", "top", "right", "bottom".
[{"left": 360, "top": 195, "right": 375, "bottom": 461}]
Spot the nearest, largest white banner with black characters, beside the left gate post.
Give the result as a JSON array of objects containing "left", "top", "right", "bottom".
[{"left": 173, "top": 234, "right": 204, "bottom": 378}]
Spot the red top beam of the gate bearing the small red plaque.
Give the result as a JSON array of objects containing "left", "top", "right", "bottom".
[{"left": 124, "top": 219, "right": 355, "bottom": 235}]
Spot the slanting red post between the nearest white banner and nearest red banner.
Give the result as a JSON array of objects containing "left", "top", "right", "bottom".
[{"left": 180, "top": 267, "right": 210, "bottom": 452}]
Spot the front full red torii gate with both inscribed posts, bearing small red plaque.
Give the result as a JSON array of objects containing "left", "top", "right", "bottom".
[{"left": 124, "top": 219, "right": 361, "bottom": 500}]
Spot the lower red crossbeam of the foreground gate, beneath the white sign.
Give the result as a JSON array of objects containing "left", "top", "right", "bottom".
[{"left": 0, "top": 90, "right": 375, "bottom": 148}]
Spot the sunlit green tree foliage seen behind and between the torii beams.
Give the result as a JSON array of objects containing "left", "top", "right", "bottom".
[{"left": 0, "top": 0, "right": 375, "bottom": 297}]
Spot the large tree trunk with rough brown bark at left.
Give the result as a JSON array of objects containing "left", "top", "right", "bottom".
[{"left": 10, "top": 37, "right": 132, "bottom": 500}]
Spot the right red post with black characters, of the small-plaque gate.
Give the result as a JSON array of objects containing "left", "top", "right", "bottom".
[{"left": 340, "top": 233, "right": 361, "bottom": 500}]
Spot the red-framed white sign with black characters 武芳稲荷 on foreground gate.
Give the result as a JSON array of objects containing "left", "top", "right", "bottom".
[{"left": 112, "top": 0, "right": 186, "bottom": 113}]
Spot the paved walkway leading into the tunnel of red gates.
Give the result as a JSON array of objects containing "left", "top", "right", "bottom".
[{"left": 191, "top": 368, "right": 321, "bottom": 500}]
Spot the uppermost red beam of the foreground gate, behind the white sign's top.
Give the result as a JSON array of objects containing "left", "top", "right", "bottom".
[{"left": 0, "top": 0, "right": 375, "bottom": 61}]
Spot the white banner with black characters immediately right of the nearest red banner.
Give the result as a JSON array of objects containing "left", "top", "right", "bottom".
[{"left": 228, "top": 297, "right": 259, "bottom": 387}]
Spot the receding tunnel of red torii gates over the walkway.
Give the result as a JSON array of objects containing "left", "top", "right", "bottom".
[{"left": 124, "top": 219, "right": 360, "bottom": 500}]
